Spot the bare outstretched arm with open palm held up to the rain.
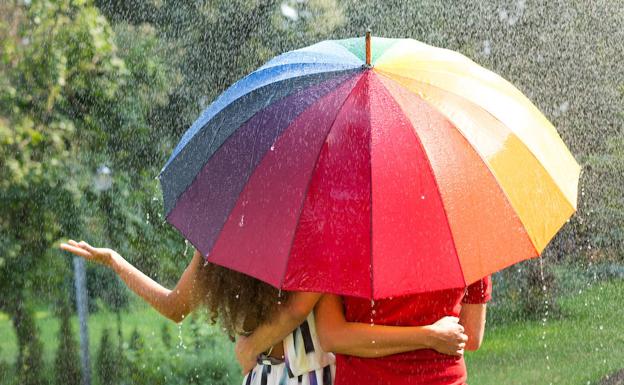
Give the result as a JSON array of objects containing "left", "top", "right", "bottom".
[{"left": 60, "top": 240, "right": 207, "bottom": 322}]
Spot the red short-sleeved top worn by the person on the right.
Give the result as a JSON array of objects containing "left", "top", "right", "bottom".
[{"left": 335, "top": 276, "right": 492, "bottom": 385}]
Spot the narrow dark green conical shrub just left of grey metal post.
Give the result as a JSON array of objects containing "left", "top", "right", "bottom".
[{"left": 54, "top": 303, "right": 82, "bottom": 385}]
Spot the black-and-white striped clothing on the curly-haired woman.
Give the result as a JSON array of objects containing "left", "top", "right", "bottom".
[{"left": 243, "top": 314, "right": 336, "bottom": 385}]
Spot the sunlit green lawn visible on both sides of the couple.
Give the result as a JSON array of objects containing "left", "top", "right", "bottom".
[{"left": 0, "top": 281, "right": 624, "bottom": 385}]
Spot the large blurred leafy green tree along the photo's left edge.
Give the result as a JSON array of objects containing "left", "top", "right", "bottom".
[{"left": 0, "top": 0, "right": 182, "bottom": 368}]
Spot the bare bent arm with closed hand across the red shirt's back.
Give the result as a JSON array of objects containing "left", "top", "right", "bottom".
[{"left": 315, "top": 295, "right": 466, "bottom": 357}]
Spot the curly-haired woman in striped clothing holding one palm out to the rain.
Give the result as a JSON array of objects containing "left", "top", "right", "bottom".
[{"left": 60, "top": 240, "right": 467, "bottom": 385}]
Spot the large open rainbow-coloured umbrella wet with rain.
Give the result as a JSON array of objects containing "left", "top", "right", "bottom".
[{"left": 159, "top": 34, "right": 580, "bottom": 298}]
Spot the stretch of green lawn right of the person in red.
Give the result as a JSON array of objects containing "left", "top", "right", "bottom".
[{"left": 466, "top": 281, "right": 624, "bottom": 385}]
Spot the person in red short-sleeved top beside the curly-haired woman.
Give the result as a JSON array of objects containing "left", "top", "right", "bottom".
[{"left": 315, "top": 276, "right": 492, "bottom": 385}]
